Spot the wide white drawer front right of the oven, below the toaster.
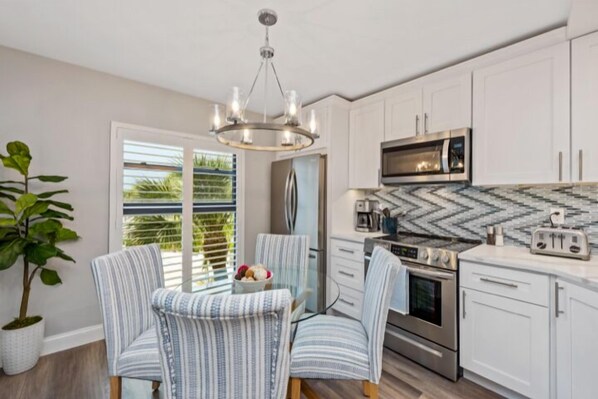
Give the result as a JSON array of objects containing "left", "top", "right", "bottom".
[{"left": 459, "top": 261, "right": 549, "bottom": 306}]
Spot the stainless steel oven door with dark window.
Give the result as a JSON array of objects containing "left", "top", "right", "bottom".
[{"left": 388, "top": 262, "right": 458, "bottom": 350}]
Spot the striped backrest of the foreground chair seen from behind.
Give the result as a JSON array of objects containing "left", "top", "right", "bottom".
[{"left": 152, "top": 289, "right": 291, "bottom": 399}]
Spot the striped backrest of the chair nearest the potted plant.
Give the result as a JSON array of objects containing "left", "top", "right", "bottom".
[{"left": 91, "top": 244, "right": 164, "bottom": 375}]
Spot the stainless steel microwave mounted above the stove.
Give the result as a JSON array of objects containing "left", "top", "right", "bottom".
[{"left": 380, "top": 128, "right": 471, "bottom": 185}]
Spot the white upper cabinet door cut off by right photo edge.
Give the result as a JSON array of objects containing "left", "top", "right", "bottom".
[{"left": 571, "top": 33, "right": 598, "bottom": 182}]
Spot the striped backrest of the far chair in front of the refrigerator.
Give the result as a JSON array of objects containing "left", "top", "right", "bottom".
[{"left": 255, "top": 234, "right": 309, "bottom": 294}]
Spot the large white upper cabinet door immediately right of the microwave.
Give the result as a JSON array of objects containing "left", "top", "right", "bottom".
[{"left": 472, "top": 43, "right": 570, "bottom": 185}]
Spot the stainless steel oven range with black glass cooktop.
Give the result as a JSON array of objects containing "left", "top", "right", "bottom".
[{"left": 364, "top": 232, "right": 481, "bottom": 381}]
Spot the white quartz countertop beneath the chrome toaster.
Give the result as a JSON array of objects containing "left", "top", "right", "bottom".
[{"left": 459, "top": 245, "right": 598, "bottom": 291}]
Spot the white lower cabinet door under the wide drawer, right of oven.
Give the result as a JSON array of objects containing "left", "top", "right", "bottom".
[{"left": 460, "top": 288, "right": 550, "bottom": 399}]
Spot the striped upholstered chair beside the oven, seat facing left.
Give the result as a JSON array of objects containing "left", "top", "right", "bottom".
[{"left": 291, "top": 248, "right": 403, "bottom": 399}]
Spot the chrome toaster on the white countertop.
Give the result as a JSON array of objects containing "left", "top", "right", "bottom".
[{"left": 530, "top": 226, "right": 590, "bottom": 260}]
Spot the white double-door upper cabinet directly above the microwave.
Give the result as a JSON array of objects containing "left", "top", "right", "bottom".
[{"left": 384, "top": 73, "right": 471, "bottom": 141}]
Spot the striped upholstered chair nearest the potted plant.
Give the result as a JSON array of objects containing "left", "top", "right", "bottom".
[{"left": 91, "top": 245, "right": 164, "bottom": 399}]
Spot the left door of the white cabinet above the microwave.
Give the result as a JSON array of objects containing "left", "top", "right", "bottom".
[{"left": 384, "top": 86, "right": 422, "bottom": 141}]
